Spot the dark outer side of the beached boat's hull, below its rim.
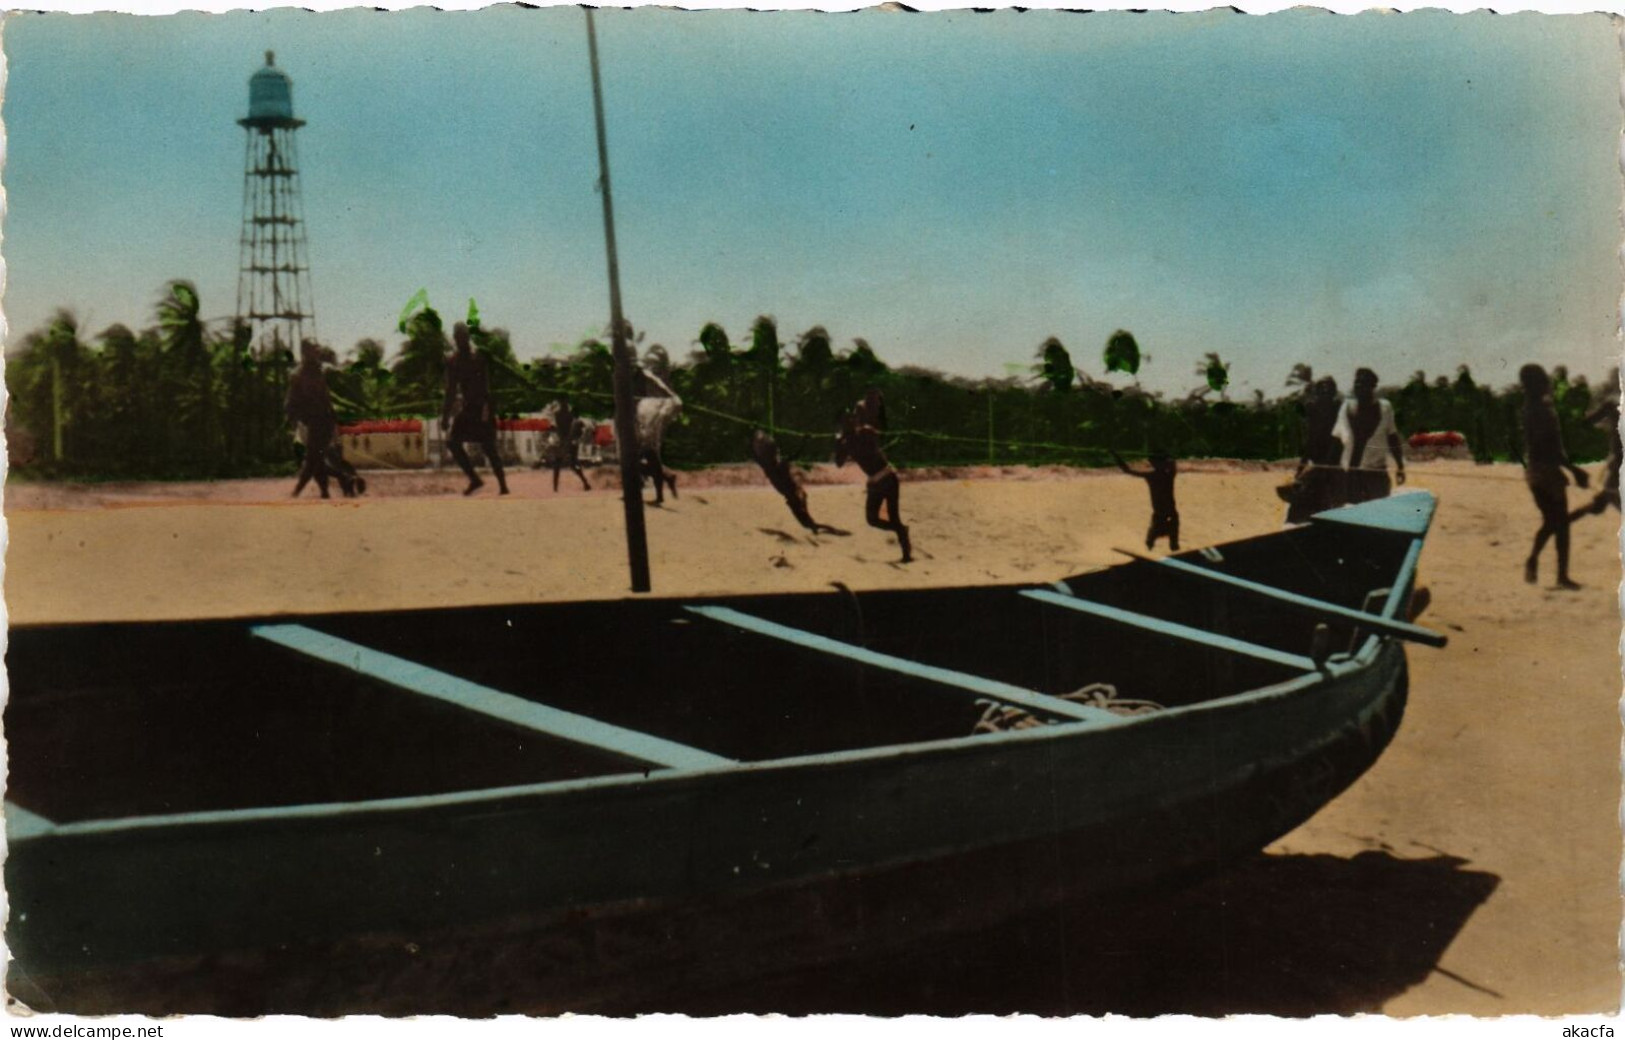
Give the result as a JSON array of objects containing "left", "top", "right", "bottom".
[{"left": 7, "top": 642, "right": 1406, "bottom": 1014}]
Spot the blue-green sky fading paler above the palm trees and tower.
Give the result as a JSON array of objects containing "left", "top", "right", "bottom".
[{"left": 3, "top": 8, "right": 1620, "bottom": 393}]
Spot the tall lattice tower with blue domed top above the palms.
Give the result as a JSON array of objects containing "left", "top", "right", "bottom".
[{"left": 237, "top": 50, "right": 315, "bottom": 353}]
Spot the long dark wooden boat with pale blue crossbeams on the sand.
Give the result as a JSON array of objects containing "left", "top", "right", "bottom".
[{"left": 5, "top": 492, "right": 1445, "bottom": 1012}]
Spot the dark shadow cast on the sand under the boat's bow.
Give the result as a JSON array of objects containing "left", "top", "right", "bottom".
[{"left": 643, "top": 852, "right": 1500, "bottom": 1017}]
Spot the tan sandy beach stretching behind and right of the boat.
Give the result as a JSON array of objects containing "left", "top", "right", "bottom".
[{"left": 5, "top": 462, "right": 1620, "bottom": 1016}]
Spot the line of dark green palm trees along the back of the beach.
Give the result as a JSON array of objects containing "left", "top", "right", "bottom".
[{"left": 7, "top": 280, "right": 1607, "bottom": 479}]
